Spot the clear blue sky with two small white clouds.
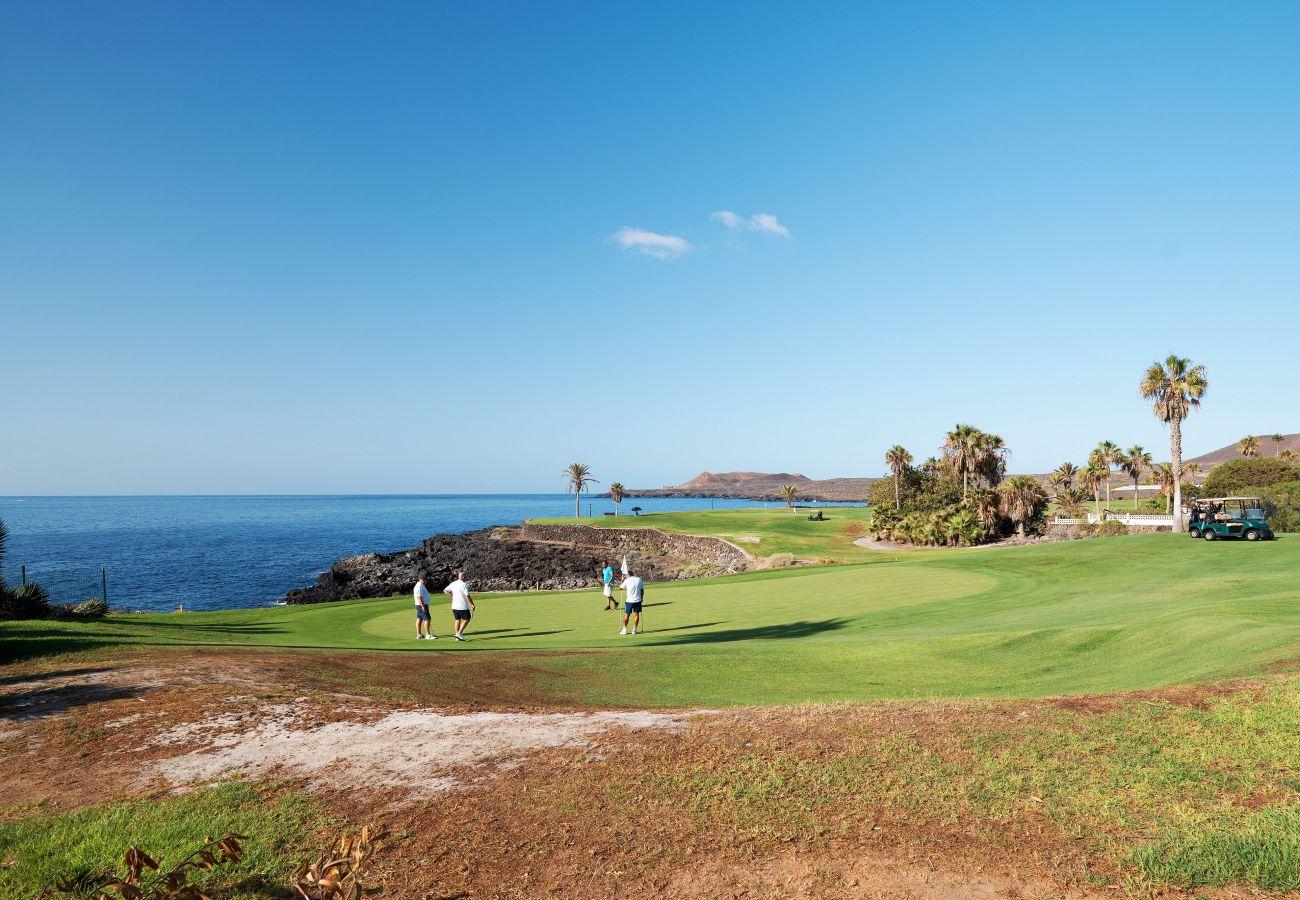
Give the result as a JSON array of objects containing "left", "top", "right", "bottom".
[{"left": 0, "top": 3, "right": 1300, "bottom": 494}]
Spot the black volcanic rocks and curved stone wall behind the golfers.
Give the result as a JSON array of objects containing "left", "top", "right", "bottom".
[{"left": 285, "top": 524, "right": 749, "bottom": 605}]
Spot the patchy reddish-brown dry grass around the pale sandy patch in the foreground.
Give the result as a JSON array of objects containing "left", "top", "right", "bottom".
[{"left": 0, "top": 650, "right": 1295, "bottom": 897}]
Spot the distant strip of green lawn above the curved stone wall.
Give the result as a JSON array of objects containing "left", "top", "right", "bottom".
[{"left": 532, "top": 501, "right": 875, "bottom": 561}]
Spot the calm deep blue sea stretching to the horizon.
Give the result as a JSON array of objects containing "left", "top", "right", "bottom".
[{"left": 0, "top": 494, "right": 790, "bottom": 610}]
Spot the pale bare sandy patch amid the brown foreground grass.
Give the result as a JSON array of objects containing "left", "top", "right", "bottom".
[{"left": 138, "top": 705, "right": 688, "bottom": 800}]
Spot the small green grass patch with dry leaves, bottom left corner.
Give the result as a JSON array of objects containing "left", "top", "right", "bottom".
[{"left": 0, "top": 783, "right": 324, "bottom": 897}]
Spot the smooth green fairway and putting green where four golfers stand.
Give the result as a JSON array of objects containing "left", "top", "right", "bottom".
[{"left": 0, "top": 535, "right": 1300, "bottom": 705}]
